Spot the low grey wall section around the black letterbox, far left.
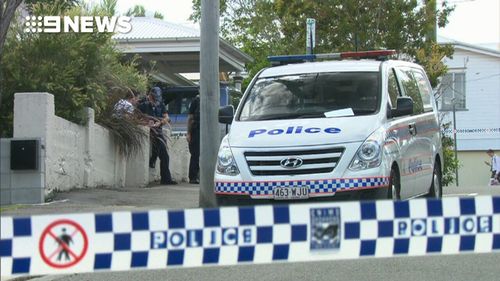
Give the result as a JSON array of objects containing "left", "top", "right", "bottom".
[{"left": 0, "top": 139, "right": 45, "bottom": 205}]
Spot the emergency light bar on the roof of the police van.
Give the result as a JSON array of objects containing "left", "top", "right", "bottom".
[{"left": 267, "top": 50, "right": 396, "bottom": 66}]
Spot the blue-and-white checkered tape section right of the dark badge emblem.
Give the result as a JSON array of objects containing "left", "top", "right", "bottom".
[{"left": 343, "top": 196, "right": 500, "bottom": 257}]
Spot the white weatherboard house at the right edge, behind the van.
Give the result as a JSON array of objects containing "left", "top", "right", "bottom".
[{"left": 438, "top": 38, "right": 500, "bottom": 186}]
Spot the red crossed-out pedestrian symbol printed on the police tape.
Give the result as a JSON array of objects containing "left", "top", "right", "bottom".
[{"left": 39, "top": 219, "right": 88, "bottom": 268}]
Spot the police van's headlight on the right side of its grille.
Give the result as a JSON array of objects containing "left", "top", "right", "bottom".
[{"left": 349, "top": 131, "right": 383, "bottom": 168}]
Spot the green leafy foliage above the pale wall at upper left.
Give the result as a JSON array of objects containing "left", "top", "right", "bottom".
[{"left": 0, "top": 0, "right": 147, "bottom": 136}]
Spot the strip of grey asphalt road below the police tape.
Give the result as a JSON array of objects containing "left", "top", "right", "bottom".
[{"left": 22, "top": 254, "right": 500, "bottom": 281}]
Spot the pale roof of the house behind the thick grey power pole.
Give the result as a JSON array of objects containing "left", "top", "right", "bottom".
[{"left": 113, "top": 17, "right": 253, "bottom": 85}]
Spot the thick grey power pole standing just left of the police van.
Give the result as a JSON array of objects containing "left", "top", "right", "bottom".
[{"left": 199, "top": 0, "right": 220, "bottom": 207}]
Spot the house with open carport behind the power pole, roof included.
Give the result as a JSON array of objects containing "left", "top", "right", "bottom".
[{"left": 113, "top": 17, "right": 252, "bottom": 134}]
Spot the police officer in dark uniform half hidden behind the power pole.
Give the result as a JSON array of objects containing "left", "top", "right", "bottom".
[{"left": 186, "top": 95, "right": 200, "bottom": 184}]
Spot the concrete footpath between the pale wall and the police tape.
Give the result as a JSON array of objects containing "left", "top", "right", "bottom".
[{"left": 0, "top": 183, "right": 199, "bottom": 216}]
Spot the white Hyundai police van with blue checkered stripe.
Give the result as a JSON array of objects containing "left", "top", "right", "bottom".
[{"left": 215, "top": 50, "right": 443, "bottom": 205}]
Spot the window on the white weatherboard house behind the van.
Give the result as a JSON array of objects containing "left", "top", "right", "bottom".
[{"left": 440, "top": 72, "right": 467, "bottom": 110}]
